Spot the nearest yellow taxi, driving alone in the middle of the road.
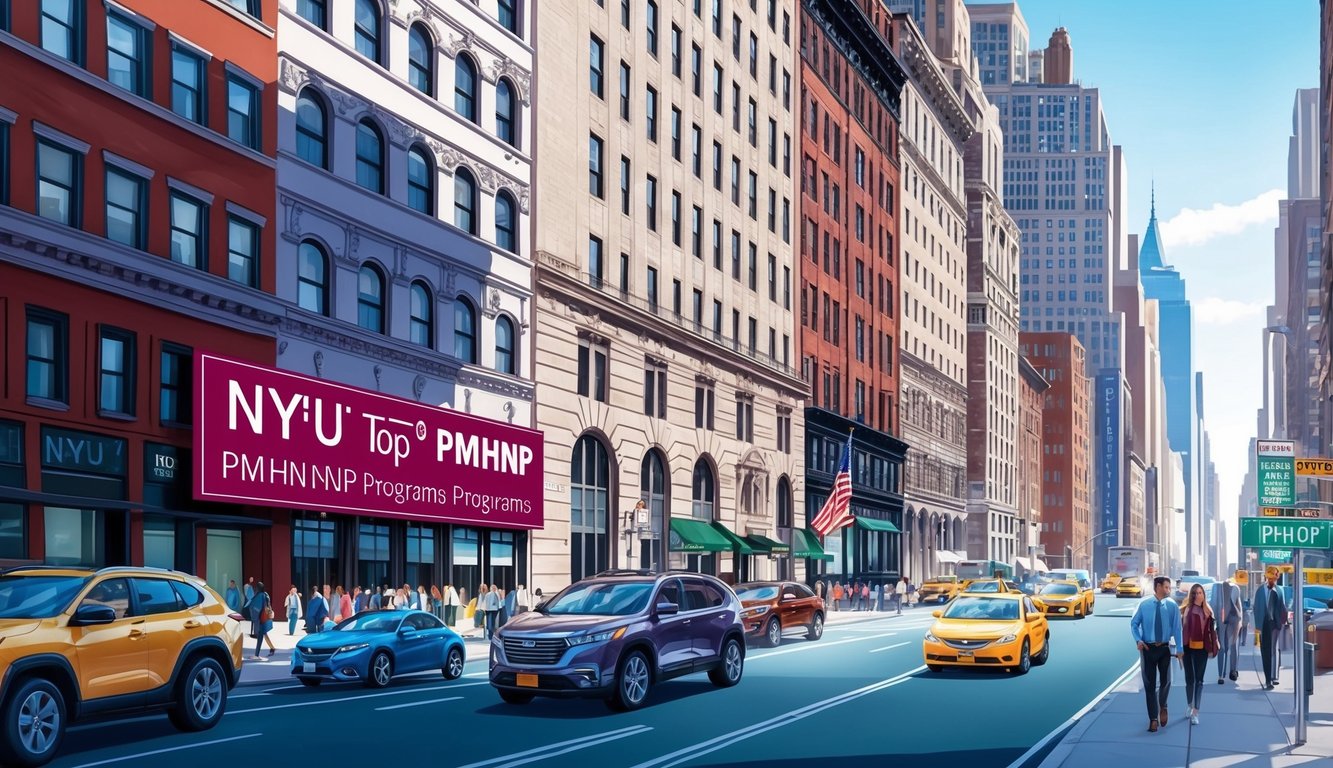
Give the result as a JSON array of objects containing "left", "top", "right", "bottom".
[{"left": 921, "top": 592, "right": 1050, "bottom": 675}]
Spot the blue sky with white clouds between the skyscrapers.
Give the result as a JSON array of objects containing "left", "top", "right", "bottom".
[{"left": 1002, "top": 0, "right": 1320, "bottom": 531}]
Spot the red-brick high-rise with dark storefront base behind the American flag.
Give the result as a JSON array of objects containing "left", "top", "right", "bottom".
[{"left": 798, "top": 0, "right": 906, "bottom": 577}]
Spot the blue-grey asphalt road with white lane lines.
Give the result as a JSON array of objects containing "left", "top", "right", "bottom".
[{"left": 52, "top": 597, "right": 1136, "bottom": 768}]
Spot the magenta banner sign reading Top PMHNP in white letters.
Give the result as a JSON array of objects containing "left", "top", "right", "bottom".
[{"left": 195, "top": 352, "right": 543, "bottom": 528}]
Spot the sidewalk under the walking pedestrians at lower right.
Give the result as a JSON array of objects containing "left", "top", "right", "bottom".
[{"left": 1041, "top": 645, "right": 1333, "bottom": 768}]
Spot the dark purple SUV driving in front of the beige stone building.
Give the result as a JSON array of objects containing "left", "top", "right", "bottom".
[{"left": 491, "top": 571, "right": 745, "bottom": 709}]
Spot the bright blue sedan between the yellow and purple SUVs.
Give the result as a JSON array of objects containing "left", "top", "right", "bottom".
[{"left": 292, "top": 611, "right": 464, "bottom": 688}]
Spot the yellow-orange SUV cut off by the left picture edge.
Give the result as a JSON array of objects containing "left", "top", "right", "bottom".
[{"left": 0, "top": 567, "right": 244, "bottom": 767}]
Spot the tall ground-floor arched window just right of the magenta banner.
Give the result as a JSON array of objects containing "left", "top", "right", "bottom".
[{"left": 569, "top": 435, "right": 611, "bottom": 581}]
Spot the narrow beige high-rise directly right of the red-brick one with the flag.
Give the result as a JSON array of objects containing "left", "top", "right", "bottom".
[{"left": 893, "top": 13, "right": 973, "bottom": 583}]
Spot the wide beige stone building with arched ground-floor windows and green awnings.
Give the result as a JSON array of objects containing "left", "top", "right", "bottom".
[{"left": 531, "top": 0, "right": 799, "bottom": 591}]
